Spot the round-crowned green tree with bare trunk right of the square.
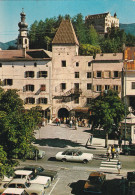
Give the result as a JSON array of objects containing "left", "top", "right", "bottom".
[{"left": 90, "top": 90, "right": 125, "bottom": 147}]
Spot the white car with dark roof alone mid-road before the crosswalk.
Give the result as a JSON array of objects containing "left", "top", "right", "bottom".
[{"left": 55, "top": 149, "right": 93, "bottom": 163}]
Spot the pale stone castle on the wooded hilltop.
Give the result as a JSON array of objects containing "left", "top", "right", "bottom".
[{"left": 85, "top": 12, "right": 119, "bottom": 34}]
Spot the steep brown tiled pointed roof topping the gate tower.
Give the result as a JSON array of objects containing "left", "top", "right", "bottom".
[{"left": 52, "top": 20, "right": 79, "bottom": 45}]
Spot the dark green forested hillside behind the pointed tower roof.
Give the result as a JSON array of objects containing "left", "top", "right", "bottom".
[{"left": 29, "top": 14, "right": 135, "bottom": 55}]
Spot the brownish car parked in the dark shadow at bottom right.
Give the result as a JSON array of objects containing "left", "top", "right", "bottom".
[{"left": 84, "top": 172, "right": 106, "bottom": 194}]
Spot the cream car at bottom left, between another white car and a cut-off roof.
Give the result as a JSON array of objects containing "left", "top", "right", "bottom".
[{"left": 3, "top": 179, "right": 45, "bottom": 195}]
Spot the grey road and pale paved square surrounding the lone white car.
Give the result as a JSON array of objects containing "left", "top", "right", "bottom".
[{"left": 20, "top": 125, "right": 135, "bottom": 195}]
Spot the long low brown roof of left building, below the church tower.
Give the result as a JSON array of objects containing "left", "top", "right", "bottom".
[{"left": 0, "top": 49, "right": 52, "bottom": 61}]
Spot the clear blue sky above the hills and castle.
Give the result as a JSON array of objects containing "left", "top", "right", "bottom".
[{"left": 0, "top": 0, "right": 135, "bottom": 43}]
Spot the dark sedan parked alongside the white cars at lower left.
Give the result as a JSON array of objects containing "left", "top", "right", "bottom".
[{"left": 23, "top": 165, "right": 57, "bottom": 180}]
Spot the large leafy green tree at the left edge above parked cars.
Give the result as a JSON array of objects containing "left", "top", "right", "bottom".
[{"left": 0, "top": 88, "right": 41, "bottom": 174}]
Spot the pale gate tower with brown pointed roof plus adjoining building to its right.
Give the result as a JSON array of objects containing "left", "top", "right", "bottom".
[{"left": 52, "top": 20, "right": 123, "bottom": 118}]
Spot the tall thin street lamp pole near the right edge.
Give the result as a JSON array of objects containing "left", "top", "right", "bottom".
[{"left": 124, "top": 59, "right": 134, "bottom": 145}]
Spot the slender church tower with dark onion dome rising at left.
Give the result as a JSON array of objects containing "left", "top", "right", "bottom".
[{"left": 18, "top": 10, "right": 29, "bottom": 49}]
